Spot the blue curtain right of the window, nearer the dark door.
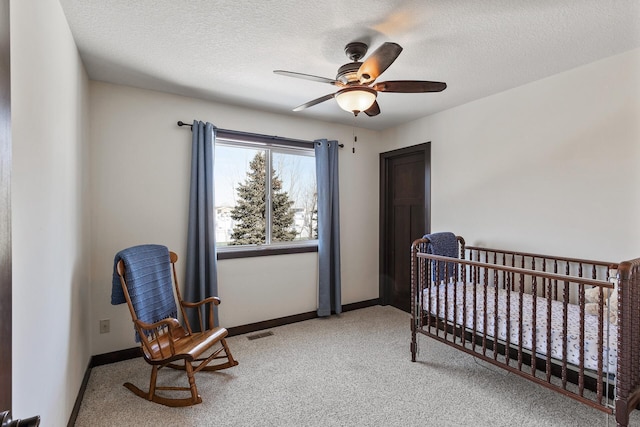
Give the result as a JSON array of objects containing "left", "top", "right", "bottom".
[{"left": 314, "top": 139, "right": 342, "bottom": 317}]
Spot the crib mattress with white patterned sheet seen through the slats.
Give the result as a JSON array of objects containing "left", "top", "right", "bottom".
[{"left": 423, "top": 283, "right": 618, "bottom": 374}]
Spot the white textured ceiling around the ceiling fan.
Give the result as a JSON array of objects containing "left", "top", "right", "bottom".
[{"left": 60, "top": 0, "right": 640, "bottom": 130}]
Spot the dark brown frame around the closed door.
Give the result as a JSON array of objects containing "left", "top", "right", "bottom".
[{"left": 378, "top": 141, "right": 431, "bottom": 305}]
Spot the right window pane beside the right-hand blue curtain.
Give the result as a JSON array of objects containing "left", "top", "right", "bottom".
[{"left": 271, "top": 152, "right": 318, "bottom": 242}]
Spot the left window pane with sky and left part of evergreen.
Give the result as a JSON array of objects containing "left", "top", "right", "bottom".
[{"left": 214, "top": 144, "right": 266, "bottom": 246}]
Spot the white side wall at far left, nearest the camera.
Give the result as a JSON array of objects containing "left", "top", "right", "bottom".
[{"left": 10, "top": 0, "right": 91, "bottom": 426}]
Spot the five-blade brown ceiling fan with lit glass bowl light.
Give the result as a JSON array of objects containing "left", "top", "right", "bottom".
[{"left": 274, "top": 42, "right": 447, "bottom": 117}]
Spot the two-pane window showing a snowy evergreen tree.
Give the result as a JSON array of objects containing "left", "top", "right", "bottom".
[{"left": 214, "top": 137, "right": 318, "bottom": 253}]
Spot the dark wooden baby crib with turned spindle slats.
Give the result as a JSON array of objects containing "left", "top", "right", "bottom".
[{"left": 411, "top": 236, "right": 640, "bottom": 426}]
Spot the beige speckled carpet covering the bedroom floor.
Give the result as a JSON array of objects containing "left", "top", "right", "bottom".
[{"left": 76, "top": 306, "right": 640, "bottom": 427}]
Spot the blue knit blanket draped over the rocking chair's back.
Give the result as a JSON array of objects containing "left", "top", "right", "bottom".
[{"left": 111, "top": 245, "right": 178, "bottom": 341}]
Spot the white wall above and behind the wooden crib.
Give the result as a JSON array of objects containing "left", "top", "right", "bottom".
[{"left": 383, "top": 50, "right": 640, "bottom": 261}]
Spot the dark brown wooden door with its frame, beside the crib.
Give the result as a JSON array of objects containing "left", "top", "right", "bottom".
[{"left": 380, "top": 143, "right": 430, "bottom": 311}]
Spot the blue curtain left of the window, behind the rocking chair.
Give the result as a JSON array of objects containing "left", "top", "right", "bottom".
[{"left": 184, "top": 121, "right": 218, "bottom": 327}]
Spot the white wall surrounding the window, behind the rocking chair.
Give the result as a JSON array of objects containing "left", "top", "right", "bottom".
[{"left": 89, "top": 82, "right": 380, "bottom": 354}]
